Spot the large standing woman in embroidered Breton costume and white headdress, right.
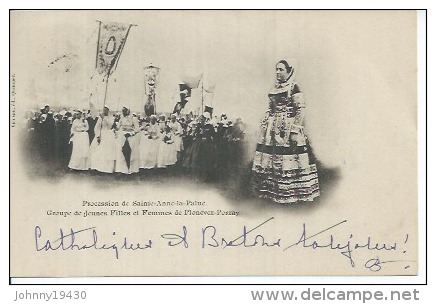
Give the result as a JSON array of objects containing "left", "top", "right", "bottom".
[{"left": 252, "top": 60, "right": 320, "bottom": 203}]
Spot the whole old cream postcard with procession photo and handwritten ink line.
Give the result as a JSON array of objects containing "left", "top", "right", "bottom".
[{"left": 10, "top": 10, "right": 419, "bottom": 278}]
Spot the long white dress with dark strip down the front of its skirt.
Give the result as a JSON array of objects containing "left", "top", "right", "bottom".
[{"left": 115, "top": 115, "right": 139, "bottom": 174}]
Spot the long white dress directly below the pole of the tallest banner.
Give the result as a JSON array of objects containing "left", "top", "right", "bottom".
[{"left": 89, "top": 116, "right": 116, "bottom": 173}]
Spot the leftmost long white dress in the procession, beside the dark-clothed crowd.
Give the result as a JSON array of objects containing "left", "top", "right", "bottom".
[{"left": 68, "top": 119, "right": 89, "bottom": 170}]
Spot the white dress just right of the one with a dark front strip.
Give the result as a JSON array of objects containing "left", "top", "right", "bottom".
[{"left": 139, "top": 123, "right": 160, "bottom": 169}]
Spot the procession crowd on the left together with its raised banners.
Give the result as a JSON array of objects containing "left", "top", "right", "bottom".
[{"left": 19, "top": 21, "right": 249, "bottom": 180}]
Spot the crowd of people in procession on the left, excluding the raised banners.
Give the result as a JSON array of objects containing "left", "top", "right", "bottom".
[{"left": 23, "top": 105, "right": 245, "bottom": 180}]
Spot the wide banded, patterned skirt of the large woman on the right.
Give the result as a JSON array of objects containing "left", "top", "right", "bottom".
[{"left": 252, "top": 115, "right": 320, "bottom": 204}]
